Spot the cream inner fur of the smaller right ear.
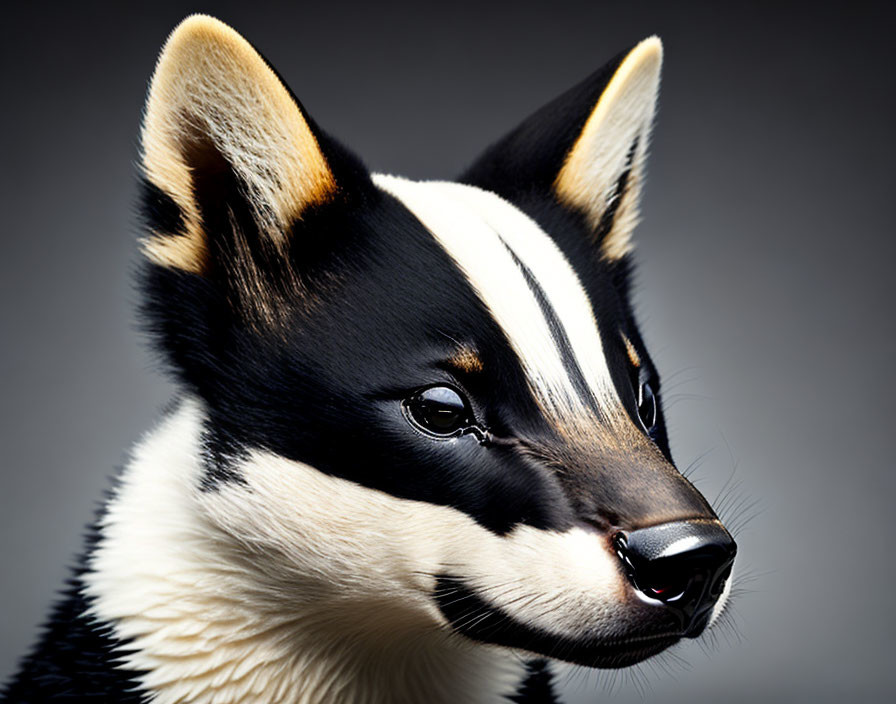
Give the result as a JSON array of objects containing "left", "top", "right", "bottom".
[{"left": 554, "top": 37, "right": 663, "bottom": 260}]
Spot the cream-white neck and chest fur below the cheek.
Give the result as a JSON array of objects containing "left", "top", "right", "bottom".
[{"left": 85, "top": 401, "right": 523, "bottom": 704}]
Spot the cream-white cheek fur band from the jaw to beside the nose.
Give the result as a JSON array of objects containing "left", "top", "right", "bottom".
[{"left": 202, "top": 452, "right": 626, "bottom": 637}]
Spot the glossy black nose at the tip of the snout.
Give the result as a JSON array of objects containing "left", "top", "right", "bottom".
[{"left": 614, "top": 520, "right": 737, "bottom": 638}]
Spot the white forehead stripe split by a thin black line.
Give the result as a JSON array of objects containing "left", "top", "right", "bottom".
[{"left": 374, "top": 175, "right": 622, "bottom": 422}]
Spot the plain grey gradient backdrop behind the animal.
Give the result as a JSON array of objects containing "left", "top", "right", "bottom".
[{"left": 0, "top": 0, "right": 896, "bottom": 702}]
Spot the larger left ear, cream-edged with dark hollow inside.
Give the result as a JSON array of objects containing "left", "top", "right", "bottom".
[{"left": 142, "top": 15, "right": 354, "bottom": 277}]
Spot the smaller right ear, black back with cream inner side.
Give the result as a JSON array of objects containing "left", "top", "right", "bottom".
[{"left": 461, "top": 37, "right": 663, "bottom": 260}]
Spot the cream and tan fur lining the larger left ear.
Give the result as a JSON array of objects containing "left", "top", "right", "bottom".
[{"left": 142, "top": 15, "right": 336, "bottom": 273}]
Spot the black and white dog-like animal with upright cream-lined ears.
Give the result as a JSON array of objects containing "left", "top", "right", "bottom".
[{"left": 5, "top": 16, "right": 735, "bottom": 704}]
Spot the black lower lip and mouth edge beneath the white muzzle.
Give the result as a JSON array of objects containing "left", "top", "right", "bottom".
[{"left": 433, "top": 575, "right": 683, "bottom": 668}]
